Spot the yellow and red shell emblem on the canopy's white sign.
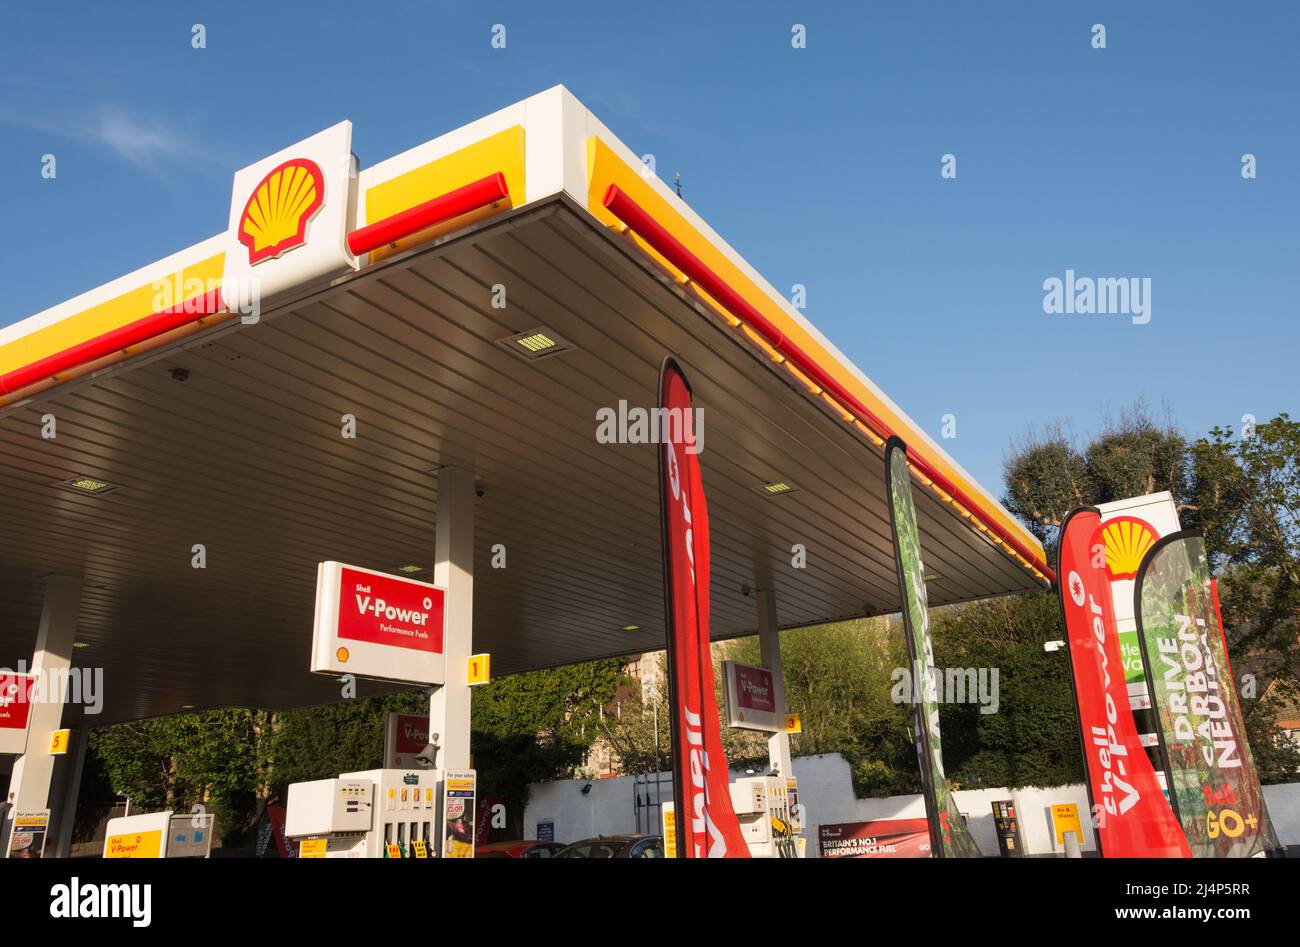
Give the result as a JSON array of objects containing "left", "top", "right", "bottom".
[{"left": 238, "top": 157, "right": 325, "bottom": 265}]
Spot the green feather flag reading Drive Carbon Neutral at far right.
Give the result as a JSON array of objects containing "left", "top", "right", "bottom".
[{"left": 1134, "top": 531, "right": 1279, "bottom": 859}]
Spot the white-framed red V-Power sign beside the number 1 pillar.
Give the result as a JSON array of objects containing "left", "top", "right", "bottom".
[{"left": 312, "top": 562, "right": 447, "bottom": 684}]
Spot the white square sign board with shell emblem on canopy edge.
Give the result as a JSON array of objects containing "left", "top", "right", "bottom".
[{"left": 221, "top": 121, "right": 356, "bottom": 313}]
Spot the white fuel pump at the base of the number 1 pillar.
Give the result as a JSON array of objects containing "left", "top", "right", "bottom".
[{"left": 285, "top": 769, "right": 476, "bottom": 859}]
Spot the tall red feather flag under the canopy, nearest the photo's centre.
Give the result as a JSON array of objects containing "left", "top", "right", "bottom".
[{"left": 659, "top": 358, "right": 749, "bottom": 859}]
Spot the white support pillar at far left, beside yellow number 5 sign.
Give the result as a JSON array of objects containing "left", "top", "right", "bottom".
[{"left": 4, "top": 575, "right": 82, "bottom": 851}]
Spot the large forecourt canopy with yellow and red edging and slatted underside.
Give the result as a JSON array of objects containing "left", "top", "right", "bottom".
[{"left": 0, "top": 87, "right": 1052, "bottom": 723}]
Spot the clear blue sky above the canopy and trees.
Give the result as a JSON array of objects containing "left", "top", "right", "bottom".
[{"left": 0, "top": 0, "right": 1300, "bottom": 493}]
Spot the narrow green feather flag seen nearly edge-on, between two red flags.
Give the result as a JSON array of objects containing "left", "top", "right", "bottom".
[{"left": 885, "top": 437, "right": 980, "bottom": 859}]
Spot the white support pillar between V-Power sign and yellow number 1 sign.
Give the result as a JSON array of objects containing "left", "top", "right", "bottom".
[{"left": 429, "top": 467, "right": 475, "bottom": 770}]
